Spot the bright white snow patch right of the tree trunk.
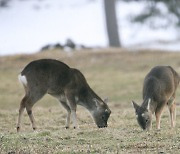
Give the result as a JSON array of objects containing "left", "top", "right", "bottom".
[{"left": 117, "top": 1, "right": 180, "bottom": 51}]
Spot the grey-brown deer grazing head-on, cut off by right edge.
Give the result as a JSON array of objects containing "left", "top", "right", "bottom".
[{"left": 132, "top": 66, "right": 180, "bottom": 130}]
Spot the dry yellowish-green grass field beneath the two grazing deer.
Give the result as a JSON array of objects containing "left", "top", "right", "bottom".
[{"left": 0, "top": 49, "right": 180, "bottom": 154}]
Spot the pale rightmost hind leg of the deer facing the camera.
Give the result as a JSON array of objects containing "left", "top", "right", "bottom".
[{"left": 168, "top": 97, "right": 176, "bottom": 128}]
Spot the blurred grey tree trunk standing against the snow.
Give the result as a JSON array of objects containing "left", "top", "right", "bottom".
[{"left": 104, "top": 0, "right": 121, "bottom": 47}]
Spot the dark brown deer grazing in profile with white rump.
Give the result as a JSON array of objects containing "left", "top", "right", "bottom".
[{"left": 17, "top": 59, "right": 111, "bottom": 132}]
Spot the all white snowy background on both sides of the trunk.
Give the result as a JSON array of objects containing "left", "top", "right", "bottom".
[{"left": 0, "top": 0, "right": 180, "bottom": 55}]
